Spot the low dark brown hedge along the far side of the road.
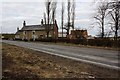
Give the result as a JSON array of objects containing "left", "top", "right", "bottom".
[{"left": 15, "top": 38, "right": 120, "bottom": 47}]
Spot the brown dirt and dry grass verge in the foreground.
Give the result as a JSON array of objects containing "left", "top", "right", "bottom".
[{"left": 2, "top": 43, "right": 119, "bottom": 80}]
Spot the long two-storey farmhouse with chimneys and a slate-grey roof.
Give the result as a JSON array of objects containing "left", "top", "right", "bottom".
[{"left": 15, "top": 20, "right": 58, "bottom": 40}]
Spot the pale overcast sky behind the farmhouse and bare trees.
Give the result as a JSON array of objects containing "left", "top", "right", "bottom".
[{"left": 0, "top": 0, "right": 118, "bottom": 36}]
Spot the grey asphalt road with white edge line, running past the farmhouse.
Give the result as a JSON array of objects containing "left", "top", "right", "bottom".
[{"left": 2, "top": 40, "right": 120, "bottom": 70}]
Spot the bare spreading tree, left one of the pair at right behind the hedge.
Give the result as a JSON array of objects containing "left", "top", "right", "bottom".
[{"left": 94, "top": 2, "right": 108, "bottom": 38}]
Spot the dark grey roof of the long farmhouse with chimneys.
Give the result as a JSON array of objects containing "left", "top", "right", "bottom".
[{"left": 21, "top": 24, "right": 54, "bottom": 31}]
